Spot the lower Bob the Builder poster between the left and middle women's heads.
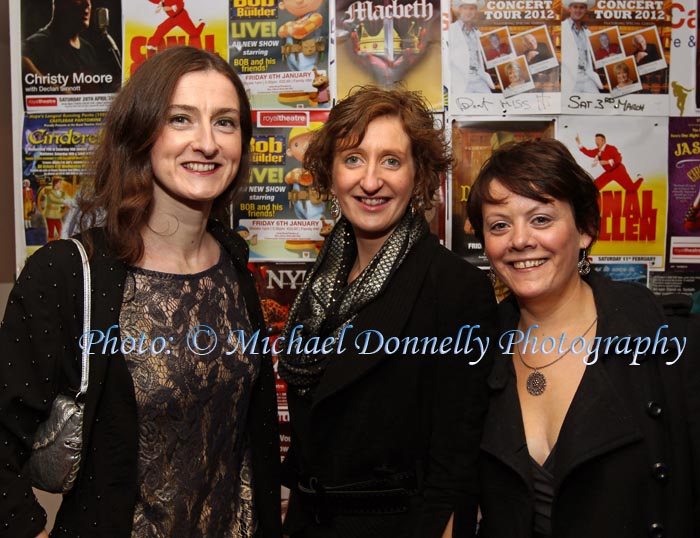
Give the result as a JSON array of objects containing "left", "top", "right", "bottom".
[{"left": 235, "top": 110, "right": 335, "bottom": 261}]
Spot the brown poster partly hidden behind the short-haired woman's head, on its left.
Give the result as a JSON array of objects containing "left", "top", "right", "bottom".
[{"left": 448, "top": 117, "right": 555, "bottom": 267}]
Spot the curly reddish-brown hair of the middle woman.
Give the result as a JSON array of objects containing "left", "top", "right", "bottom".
[{"left": 304, "top": 86, "right": 452, "bottom": 210}]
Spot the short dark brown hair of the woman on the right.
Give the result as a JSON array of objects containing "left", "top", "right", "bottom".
[{"left": 467, "top": 138, "right": 600, "bottom": 244}]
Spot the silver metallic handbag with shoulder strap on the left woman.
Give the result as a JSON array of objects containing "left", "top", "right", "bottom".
[{"left": 28, "top": 239, "right": 91, "bottom": 493}]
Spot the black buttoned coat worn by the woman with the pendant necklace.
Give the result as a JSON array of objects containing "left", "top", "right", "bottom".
[{"left": 480, "top": 274, "right": 700, "bottom": 538}]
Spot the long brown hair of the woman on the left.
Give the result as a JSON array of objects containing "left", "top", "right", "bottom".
[{"left": 78, "top": 46, "right": 253, "bottom": 263}]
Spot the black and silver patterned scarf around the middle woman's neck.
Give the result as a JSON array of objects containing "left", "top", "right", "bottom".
[{"left": 278, "top": 209, "right": 428, "bottom": 397}]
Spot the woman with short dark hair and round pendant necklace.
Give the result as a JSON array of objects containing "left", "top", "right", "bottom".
[{"left": 467, "top": 140, "right": 700, "bottom": 538}]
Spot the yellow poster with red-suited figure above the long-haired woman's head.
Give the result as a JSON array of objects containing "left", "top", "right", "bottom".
[{"left": 123, "top": 0, "right": 229, "bottom": 80}]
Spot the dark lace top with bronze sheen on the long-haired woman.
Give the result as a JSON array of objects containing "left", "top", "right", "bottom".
[{"left": 119, "top": 253, "right": 259, "bottom": 538}]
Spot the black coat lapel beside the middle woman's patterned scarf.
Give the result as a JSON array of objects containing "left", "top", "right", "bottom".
[{"left": 313, "top": 235, "right": 439, "bottom": 407}]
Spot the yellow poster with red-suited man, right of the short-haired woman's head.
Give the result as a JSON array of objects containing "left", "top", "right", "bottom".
[{"left": 557, "top": 116, "right": 668, "bottom": 271}]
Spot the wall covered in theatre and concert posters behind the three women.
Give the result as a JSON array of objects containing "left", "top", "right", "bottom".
[{"left": 12, "top": 0, "right": 700, "bottom": 464}]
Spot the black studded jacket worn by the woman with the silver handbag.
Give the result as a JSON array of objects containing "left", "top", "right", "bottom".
[{"left": 0, "top": 223, "right": 280, "bottom": 538}]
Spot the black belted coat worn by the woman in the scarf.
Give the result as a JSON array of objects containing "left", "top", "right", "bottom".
[{"left": 283, "top": 235, "right": 495, "bottom": 538}]
